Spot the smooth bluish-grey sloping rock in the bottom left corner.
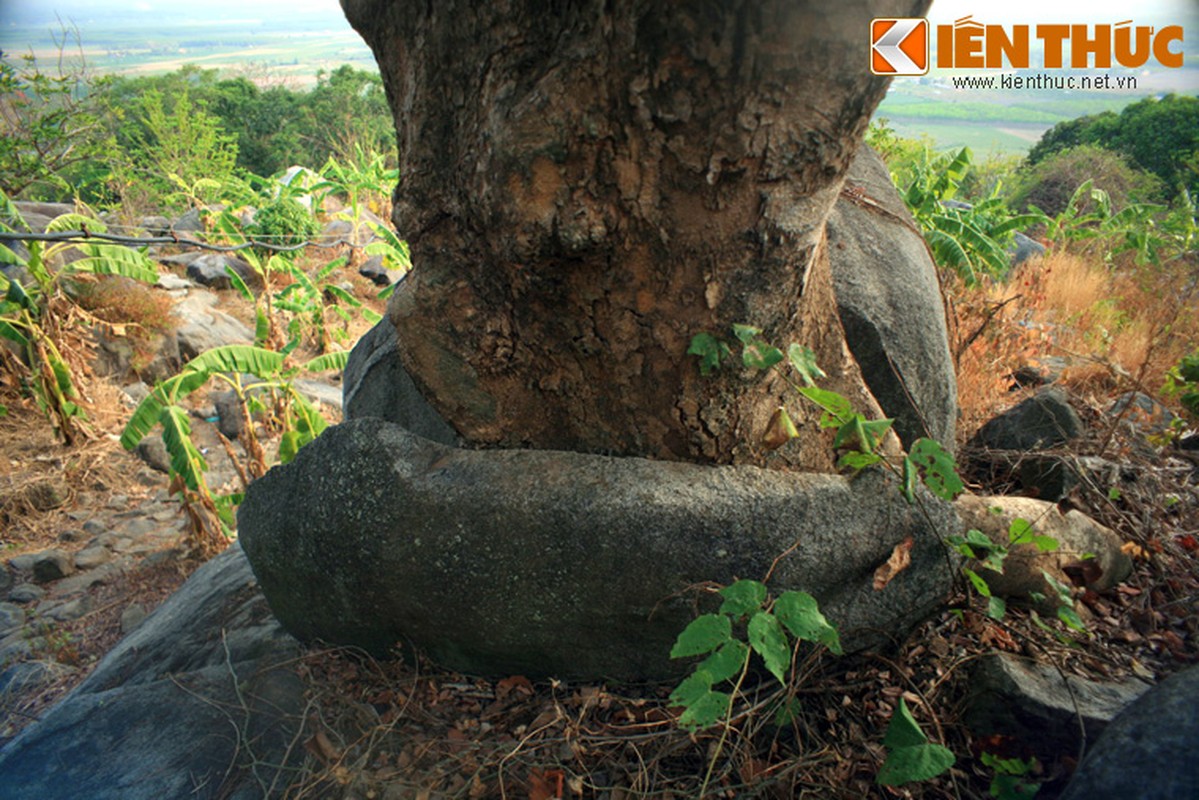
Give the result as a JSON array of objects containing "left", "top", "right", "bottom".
[{"left": 0, "top": 546, "right": 303, "bottom": 800}]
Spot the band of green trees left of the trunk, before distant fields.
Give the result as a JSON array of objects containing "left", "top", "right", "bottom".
[{"left": 0, "top": 58, "right": 396, "bottom": 211}]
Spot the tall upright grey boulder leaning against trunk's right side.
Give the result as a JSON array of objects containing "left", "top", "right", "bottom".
[{"left": 827, "top": 145, "right": 958, "bottom": 447}]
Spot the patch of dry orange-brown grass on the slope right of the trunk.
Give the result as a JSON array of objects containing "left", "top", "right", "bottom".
[{"left": 947, "top": 252, "right": 1199, "bottom": 443}]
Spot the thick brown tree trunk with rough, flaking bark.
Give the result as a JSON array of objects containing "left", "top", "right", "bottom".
[{"left": 342, "top": 0, "right": 928, "bottom": 471}]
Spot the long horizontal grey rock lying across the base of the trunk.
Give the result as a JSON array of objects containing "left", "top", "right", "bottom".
[{"left": 239, "top": 417, "right": 957, "bottom": 680}]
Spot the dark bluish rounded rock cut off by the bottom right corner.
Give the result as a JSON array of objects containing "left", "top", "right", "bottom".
[{"left": 1061, "top": 667, "right": 1199, "bottom": 800}]
